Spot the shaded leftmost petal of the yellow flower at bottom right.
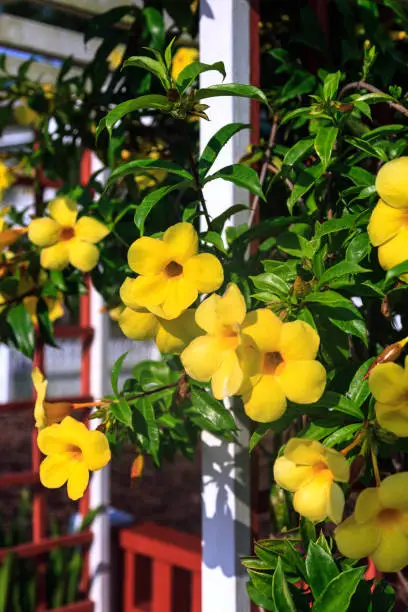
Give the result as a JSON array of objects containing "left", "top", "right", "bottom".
[{"left": 334, "top": 516, "right": 381, "bottom": 559}]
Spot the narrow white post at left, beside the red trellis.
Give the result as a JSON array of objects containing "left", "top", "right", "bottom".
[{"left": 89, "top": 155, "right": 111, "bottom": 612}]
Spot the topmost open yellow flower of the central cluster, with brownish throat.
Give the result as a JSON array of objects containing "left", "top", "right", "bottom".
[{"left": 122, "top": 223, "right": 224, "bottom": 319}]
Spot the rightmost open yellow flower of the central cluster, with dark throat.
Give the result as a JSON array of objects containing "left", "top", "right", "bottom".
[{"left": 241, "top": 308, "right": 326, "bottom": 423}]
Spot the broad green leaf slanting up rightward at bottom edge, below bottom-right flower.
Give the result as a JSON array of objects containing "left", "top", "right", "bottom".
[{"left": 313, "top": 567, "right": 367, "bottom": 612}]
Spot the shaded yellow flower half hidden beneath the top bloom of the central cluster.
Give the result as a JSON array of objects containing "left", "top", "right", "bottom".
[{"left": 119, "top": 302, "right": 204, "bottom": 355}]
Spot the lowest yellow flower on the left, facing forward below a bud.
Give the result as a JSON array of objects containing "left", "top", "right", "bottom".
[{"left": 37, "top": 416, "right": 111, "bottom": 500}]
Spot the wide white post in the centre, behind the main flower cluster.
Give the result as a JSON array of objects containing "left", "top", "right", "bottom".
[{"left": 200, "top": 0, "right": 251, "bottom": 612}]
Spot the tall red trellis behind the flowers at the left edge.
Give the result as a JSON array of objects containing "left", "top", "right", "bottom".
[{"left": 0, "top": 151, "right": 94, "bottom": 612}]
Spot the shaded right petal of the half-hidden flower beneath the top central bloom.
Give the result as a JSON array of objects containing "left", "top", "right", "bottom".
[{"left": 156, "top": 308, "right": 203, "bottom": 355}]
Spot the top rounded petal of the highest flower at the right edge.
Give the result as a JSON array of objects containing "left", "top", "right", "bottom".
[{"left": 375, "top": 157, "right": 408, "bottom": 208}]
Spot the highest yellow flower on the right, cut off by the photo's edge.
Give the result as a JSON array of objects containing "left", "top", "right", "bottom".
[{"left": 367, "top": 157, "right": 408, "bottom": 281}]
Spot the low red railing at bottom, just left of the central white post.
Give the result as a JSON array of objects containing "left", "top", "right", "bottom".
[{"left": 120, "top": 523, "right": 201, "bottom": 612}]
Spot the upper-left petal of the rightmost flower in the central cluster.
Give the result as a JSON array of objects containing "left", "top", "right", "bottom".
[{"left": 242, "top": 308, "right": 283, "bottom": 353}]
